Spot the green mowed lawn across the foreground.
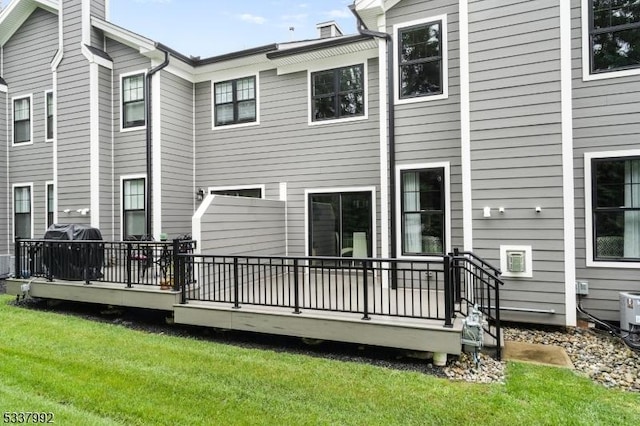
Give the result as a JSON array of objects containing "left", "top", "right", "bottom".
[{"left": 0, "top": 296, "right": 640, "bottom": 426}]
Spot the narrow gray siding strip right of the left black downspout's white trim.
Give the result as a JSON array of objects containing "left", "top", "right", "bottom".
[{"left": 160, "top": 71, "right": 195, "bottom": 238}]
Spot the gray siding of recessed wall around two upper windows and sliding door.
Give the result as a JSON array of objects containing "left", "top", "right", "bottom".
[{"left": 195, "top": 60, "right": 380, "bottom": 255}]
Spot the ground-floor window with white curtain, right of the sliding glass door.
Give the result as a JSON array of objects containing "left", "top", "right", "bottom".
[{"left": 400, "top": 168, "right": 445, "bottom": 256}]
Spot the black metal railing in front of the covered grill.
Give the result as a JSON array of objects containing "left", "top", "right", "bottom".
[{"left": 14, "top": 239, "right": 195, "bottom": 290}]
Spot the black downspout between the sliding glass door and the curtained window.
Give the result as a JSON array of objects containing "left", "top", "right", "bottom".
[{"left": 349, "top": 5, "right": 398, "bottom": 260}]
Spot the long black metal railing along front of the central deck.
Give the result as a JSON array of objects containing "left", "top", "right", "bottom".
[{"left": 178, "top": 255, "right": 454, "bottom": 326}]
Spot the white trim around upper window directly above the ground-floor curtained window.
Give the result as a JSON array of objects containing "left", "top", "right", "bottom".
[{"left": 393, "top": 14, "right": 449, "bottom": 105}]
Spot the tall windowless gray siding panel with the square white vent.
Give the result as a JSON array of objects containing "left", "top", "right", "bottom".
[{"left": 469, "top": 0, "right": 565, "bottom": 324}]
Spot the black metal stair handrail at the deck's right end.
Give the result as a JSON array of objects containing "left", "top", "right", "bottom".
[{"left": 449, "top": 249, "right": 504, "bottom": 359}]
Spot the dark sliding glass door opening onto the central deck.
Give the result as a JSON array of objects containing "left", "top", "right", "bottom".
[{"left": 308, "top": 191, "right": 373, "bottom": 258}]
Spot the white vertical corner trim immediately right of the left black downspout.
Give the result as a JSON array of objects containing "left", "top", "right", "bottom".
[{"left": 152, "top": 73, "right": 162, "bottom": 241}]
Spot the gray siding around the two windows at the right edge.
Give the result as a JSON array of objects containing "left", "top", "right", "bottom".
[{"left": 571, "top": 0, "right": 640, "bottom": 321}]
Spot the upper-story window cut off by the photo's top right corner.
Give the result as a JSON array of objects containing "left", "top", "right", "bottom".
[{"left": 588, "top": 0, "right": 640, "bottom": 73}]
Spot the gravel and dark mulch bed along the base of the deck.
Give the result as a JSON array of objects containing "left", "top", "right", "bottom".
[{"left": 0, "top": 290, "right": 640, "bottom": 392}]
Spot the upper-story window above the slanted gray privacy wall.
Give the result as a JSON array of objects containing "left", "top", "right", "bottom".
[{"left": 214, "top": 76, "right": 257, "bottom": 127}]
